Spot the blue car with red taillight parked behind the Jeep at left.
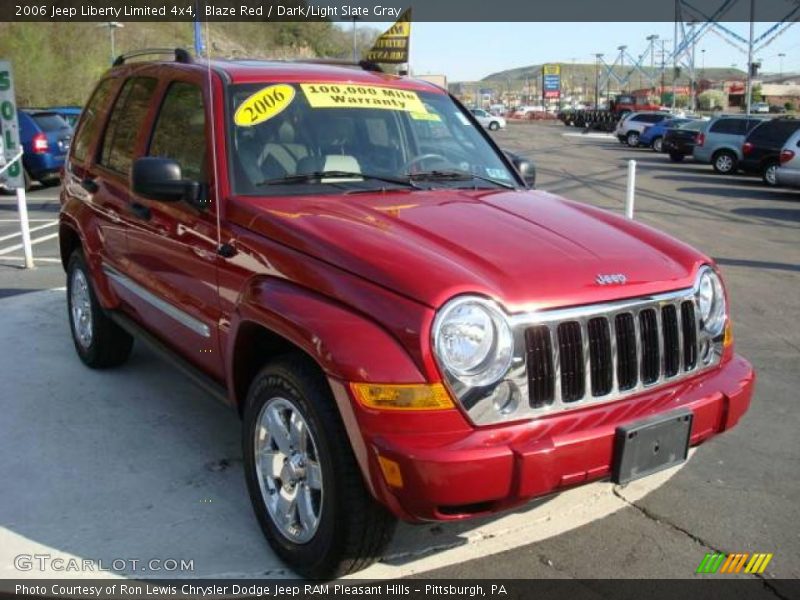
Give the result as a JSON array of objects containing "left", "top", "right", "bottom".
[{"left": 17, "top": 109, "right": 72, "bottom": 189}]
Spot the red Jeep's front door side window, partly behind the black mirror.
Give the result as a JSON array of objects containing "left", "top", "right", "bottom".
[{"left": 148, "top": 83, "right": 206, "bottom": 181}]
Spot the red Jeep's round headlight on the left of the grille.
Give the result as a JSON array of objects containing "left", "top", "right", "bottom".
[{"left": 433, "top": 297, "right": 514, "bottom": 387}]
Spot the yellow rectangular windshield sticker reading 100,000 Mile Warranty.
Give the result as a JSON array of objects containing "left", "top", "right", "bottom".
[{"left": 300, "top": 83, "right": 428, "bottom": 114}]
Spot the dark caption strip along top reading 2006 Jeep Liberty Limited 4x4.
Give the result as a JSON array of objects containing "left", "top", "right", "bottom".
[{"left": 0, "top": 0, "right": 798, "bottom": 23}]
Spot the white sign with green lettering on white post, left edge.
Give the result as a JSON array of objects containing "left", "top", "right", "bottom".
[{"left": 0, "top": 60, "right": 34, "bottom": 269}]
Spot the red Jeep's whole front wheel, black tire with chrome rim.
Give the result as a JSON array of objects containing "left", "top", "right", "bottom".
[{"left": 242, "top": 355, "right": 396, "bottom": 579}]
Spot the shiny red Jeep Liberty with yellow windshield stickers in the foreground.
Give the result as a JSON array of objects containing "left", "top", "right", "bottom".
[{"left": 59, "top": 51, "right": 754, "bottom": 578}]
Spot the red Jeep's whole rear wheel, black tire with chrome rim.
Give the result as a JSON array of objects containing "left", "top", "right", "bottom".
[{"left": 67, "top": 250, "right": 133, "bottom": 369}]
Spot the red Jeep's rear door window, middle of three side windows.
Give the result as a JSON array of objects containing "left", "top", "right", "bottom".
[{"left": 100, "top": 77, "right": 156, "bottom": 174}]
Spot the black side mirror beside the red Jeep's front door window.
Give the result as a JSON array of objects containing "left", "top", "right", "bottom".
[{"left": 131, "top": 156, "right": 200, "bottom": 205}]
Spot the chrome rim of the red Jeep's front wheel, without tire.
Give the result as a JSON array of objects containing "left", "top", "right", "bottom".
[{"left": 253, "top": 398, "right": 323, "bottom": 544}]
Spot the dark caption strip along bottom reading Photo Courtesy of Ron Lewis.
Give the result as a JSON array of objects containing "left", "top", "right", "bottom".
[{"left": 0, "top": 570, "right": 800, "bottom": 600}]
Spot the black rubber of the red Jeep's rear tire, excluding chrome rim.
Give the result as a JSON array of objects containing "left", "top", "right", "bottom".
[{"left": 67, "top": 250, "right": 133, "bottom": 369}]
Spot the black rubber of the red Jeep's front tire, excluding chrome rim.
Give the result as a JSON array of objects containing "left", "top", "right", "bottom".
[{"left": 242, "top": 355, "right": 397, "bottom": 580}]
